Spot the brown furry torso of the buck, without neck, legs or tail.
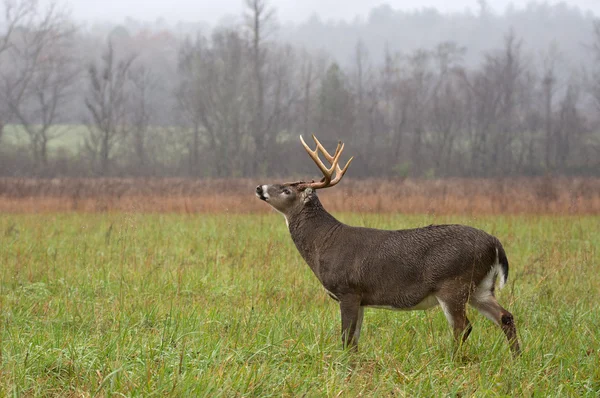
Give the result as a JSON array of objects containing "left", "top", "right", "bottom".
[{"left": 319, "top": 225, "right": 502, "bottom": 307}]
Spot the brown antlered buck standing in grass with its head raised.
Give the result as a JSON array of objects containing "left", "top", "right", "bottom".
[{"left": 256, "top": 135, "right": 520, "bottom": 356}]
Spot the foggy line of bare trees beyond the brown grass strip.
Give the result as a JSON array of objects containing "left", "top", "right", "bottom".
[{"left": 0, "top": 0, "right": 600, "bottom": 177}]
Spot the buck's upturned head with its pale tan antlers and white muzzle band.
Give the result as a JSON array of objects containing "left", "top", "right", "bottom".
[{"left": 256, "top": 135, "right": 353, "bottom": 217}]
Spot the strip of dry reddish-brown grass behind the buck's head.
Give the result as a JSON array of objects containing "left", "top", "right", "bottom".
[{"left": 0, "top": 177, "right": 600, "bottom": 214}]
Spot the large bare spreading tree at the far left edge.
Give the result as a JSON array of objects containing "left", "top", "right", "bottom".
[{"left": 3, "top": 1, "right": 78, "bottom": 173}]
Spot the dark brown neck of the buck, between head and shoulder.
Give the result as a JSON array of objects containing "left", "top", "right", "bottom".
[{"left": 288, "top": 195, "right": 343, "bottom": 276}]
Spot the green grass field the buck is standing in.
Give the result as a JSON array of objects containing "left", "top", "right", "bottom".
[{"left": 0, "top": 214, "right": 600, "bottom": 397}]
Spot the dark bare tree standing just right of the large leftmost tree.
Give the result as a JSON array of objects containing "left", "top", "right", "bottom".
[{"left": 85, "top": 41, "right": 135, "bottom": 176}]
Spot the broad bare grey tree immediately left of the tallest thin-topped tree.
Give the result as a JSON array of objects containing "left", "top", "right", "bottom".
[{"left": 180, "top": 29, "right": 253, "bottom": 177}]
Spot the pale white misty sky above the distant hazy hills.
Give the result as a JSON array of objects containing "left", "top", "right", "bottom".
[{"left": 57, "top": 0, "right": 600, "bottom": 24}]
